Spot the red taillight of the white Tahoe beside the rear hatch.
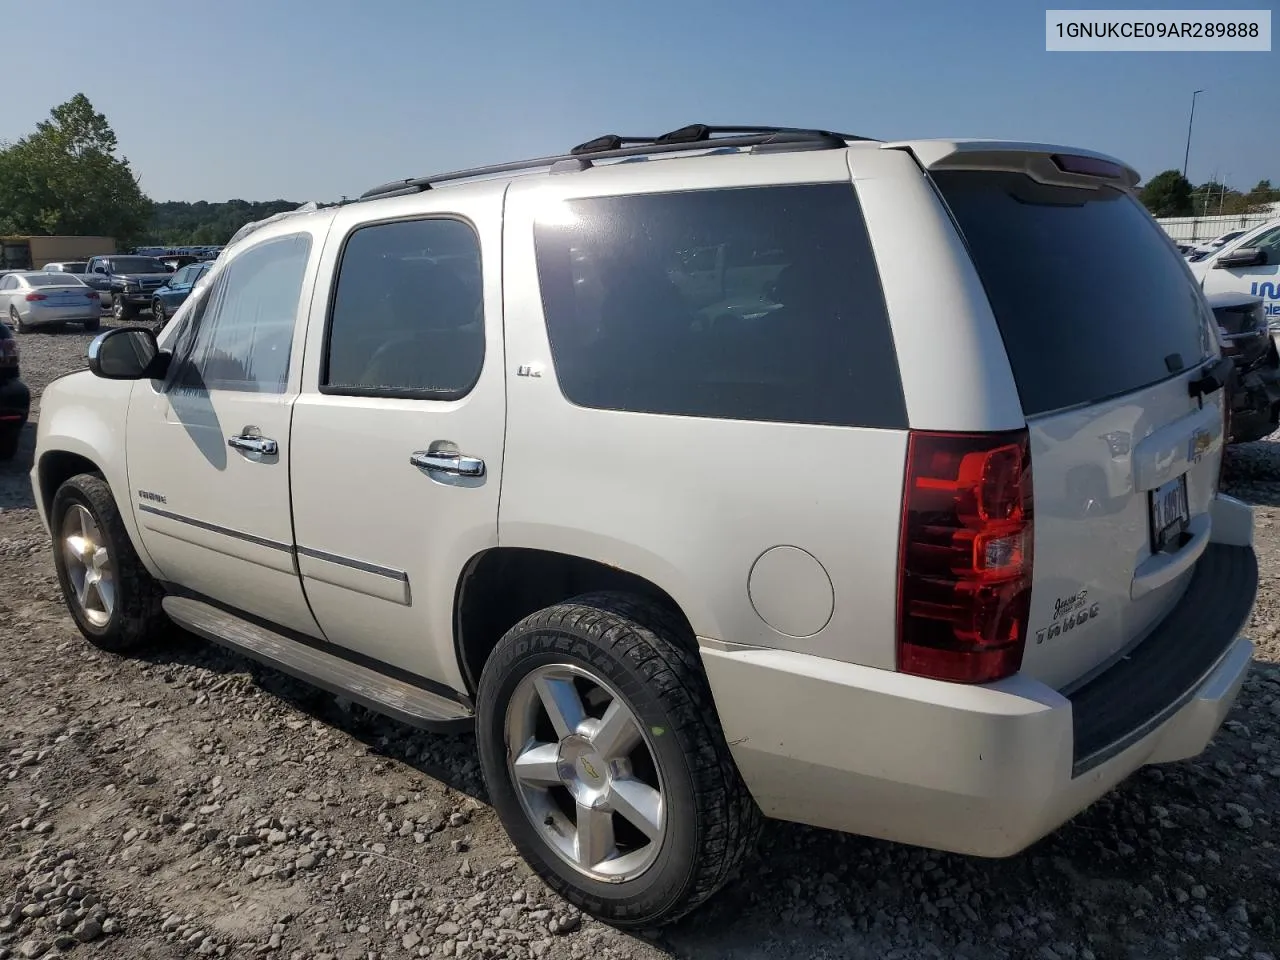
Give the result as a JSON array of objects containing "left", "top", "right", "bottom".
[{"left": 897, "top": 429, "right": 1034, "bottom": 684}]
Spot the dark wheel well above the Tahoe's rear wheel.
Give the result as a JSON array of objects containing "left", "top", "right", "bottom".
[{"left": 453, "top": 547, "right": 694, "bottom": 694}]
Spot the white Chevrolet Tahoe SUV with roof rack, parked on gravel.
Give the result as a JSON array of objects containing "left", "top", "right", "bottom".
[{"left": 32, "top": 127, "right": 1257, "bottom": 925}]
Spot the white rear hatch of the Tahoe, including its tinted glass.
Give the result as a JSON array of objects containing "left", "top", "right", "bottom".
[{"left": 931, "top": 154, "right": 1222, "bottom": 689}]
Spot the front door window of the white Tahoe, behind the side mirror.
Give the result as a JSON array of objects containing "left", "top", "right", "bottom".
[{"left": 174, "top": 234, "right": 311, "bottom": 393}]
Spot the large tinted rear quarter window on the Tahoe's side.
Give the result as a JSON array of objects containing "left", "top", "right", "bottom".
[{"left": 535, "top": 183, "right": 906, "bottom": 428}]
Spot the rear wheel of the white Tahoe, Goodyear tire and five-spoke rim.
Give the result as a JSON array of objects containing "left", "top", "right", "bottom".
[{"left": 476, "top": 593, "right": 760, "bottom": 928}]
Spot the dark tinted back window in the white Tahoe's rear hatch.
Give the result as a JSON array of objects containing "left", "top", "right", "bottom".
[{"left": 933, "top": 170, "right": 1213, "bottom": 416}]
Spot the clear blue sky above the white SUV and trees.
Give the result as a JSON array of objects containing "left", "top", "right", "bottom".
[{"left": 0, "top": 0, "right": 1280, "bottom": 202}]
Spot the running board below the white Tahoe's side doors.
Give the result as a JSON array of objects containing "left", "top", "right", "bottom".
[{"left": 163, "top": 596, "right": 472, "bottom": 732}]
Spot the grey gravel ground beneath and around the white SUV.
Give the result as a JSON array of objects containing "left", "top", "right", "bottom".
[{"left": 0, "top": 330, "right": 1280, "bottom": 960}]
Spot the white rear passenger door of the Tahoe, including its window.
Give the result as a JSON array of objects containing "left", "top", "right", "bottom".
[{"left": 292, "top": 197, "right": 506, "bottom": 690}]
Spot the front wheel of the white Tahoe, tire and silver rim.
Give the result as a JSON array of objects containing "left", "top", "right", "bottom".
[{"left": 50, "top": 474, "right": 168, "bottom": 653}]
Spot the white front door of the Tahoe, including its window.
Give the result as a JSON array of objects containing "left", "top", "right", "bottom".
[{"left": 127, "top": 227, "right": 323, "bottom": 636}]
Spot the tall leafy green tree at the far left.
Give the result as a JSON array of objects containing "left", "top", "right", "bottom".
[{"left": 0, "top": 93, "right": 151, "bottom": 243}]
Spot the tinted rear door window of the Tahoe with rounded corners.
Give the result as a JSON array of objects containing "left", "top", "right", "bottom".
[{"left": 320, "top": 218, "right": 484, "bottom": 399}]
